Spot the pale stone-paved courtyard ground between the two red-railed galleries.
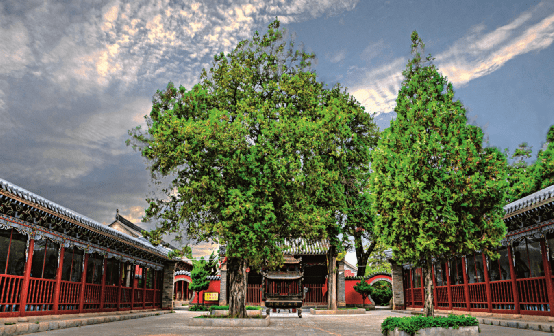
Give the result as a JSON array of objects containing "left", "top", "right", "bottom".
[{"left": 42, "top": 311, "right": 552, "bottom": 336}]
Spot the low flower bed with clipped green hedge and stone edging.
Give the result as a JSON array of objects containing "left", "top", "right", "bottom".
[{"left": 381, "top": 314, "right": 479, "bottom": 336}]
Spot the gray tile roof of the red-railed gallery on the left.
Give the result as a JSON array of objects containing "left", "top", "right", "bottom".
[{"left": 0, "top": 178, "right": 170, "bottom": 256}]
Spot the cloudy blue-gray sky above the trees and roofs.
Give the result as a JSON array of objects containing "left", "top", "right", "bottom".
[{"left": 0, "top": 0, "right": 554, "bottom": 263}]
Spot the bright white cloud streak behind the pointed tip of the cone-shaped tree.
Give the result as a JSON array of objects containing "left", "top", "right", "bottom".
[{"left": 347, "top": 2, "right": 554, "bottom": 114}]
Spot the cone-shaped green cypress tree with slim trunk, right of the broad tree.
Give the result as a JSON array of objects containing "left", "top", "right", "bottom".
[{"left": 370, "top": 31, "right": 507, "bottom": 316}]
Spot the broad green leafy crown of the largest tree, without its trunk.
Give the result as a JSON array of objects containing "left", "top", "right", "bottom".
[{"left": 127, "top": 20, "right": 376, "bottom": 268}]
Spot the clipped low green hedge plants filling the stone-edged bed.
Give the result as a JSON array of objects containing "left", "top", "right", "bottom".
[{"left": 381, "top": 314, "right": 479, "bottom": 336}]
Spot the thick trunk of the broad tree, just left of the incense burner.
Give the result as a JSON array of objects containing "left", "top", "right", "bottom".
[{"left": 227, "top": 258, "right": 247, "bottom": 318}]
